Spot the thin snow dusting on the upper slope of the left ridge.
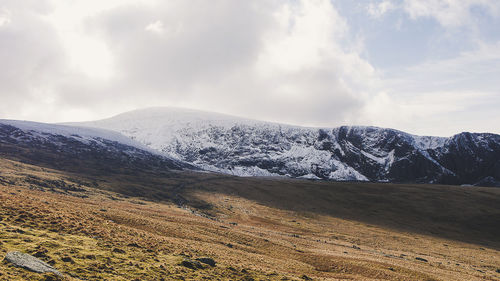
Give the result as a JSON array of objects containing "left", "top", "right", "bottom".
[{"left": 0, "top": 119, "right": 192, "bottom": 169}]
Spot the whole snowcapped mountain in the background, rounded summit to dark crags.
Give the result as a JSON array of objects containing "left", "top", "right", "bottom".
[{"left": 75, "top": 108, "right": 500, "bottom": 185}]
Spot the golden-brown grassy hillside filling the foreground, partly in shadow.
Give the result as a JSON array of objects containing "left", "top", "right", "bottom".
[{"left": 0, "top": 158, "right": 500, "bottom": 280}]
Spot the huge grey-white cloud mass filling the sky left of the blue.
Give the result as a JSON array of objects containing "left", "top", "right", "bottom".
[{"left": 0, "top": 0, "right": 375, "bottom": 125}]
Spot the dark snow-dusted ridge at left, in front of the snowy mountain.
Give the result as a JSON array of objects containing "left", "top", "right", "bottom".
[{"left": 0, "top": 120, "right": 195, "bottom": 174}]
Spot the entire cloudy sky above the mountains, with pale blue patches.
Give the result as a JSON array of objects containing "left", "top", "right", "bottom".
[{"left": 0, "top": 0, "right": 500, "bottom": 136}]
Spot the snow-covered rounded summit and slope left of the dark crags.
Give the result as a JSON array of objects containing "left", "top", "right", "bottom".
[{"left": 76, "top": 108, "right": 367, "bottom": 180}]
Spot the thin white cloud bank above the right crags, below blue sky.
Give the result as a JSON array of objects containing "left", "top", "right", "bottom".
[{"left": 361, "top": 43, "right": 500, "bottom": 136}]
